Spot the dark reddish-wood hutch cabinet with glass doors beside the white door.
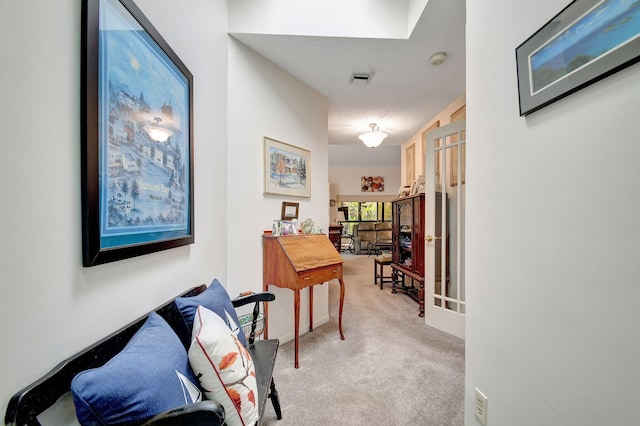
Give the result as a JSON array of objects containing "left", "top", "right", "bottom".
[{"left": 391, "top": 193, "right": 442, "bottom": 317}]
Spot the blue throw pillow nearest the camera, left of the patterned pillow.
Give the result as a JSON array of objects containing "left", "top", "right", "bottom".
[{"left": 71, "top": 312, "right": 202, "bottom": 426}]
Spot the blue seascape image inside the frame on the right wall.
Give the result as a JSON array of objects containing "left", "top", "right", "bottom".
[{"left": 529, "top": 0, "right": 640, "bottom": 94}]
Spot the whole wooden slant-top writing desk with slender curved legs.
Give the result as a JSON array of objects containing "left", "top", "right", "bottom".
[{"left": 262, "top": 234, "right": 344, "bottom": 368}]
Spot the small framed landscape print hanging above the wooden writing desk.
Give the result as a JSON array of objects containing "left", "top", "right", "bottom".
[{"left": 263, "top": 136, "right": 311, "bottom": 197}]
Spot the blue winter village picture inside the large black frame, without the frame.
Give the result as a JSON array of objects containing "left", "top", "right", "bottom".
[{"left": 99, "top": 0, "right": 190, "bottom": 247}]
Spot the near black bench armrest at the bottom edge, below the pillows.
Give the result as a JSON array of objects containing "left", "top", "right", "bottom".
[{"left": 142, "top": 400, "right": 224, "bottom": 426}]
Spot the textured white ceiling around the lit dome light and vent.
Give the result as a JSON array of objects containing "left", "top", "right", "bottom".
[{"left": 232, "top": 0, "right": 465, "bottom": 167}]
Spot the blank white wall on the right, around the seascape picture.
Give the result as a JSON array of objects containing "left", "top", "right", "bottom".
[{"left": 465, "top": 0, "right": 640, "bottom": 426}]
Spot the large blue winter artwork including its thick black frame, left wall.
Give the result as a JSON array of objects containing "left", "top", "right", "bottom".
[{"left": 81, "top": 0, "right": 194, "bottom": 266}]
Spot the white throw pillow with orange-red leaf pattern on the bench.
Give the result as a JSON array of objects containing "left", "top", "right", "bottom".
[{"left": 189, "top": 306, "right": 259, "bottom": 426}]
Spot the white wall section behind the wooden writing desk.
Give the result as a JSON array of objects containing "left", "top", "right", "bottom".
[{"left": 228, "top": 39, "right": 329, "bottom": 341}]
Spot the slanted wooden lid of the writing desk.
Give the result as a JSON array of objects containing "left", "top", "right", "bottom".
[{"left": 263, "top": 234, "right": 343, "bottom": 272}]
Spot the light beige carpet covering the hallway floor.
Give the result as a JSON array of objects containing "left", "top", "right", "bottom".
[{"left": 261, "top": 256, "right": 464, "bottom": 426}]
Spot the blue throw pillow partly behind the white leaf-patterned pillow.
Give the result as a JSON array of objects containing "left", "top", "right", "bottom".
[{"left": 176, "top": 278, "right": 247, "bottom": 346}]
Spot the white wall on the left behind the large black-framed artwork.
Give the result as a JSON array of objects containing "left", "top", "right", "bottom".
[{"left": 0, "top": 0, "right": 227, "bottom": 413}]
